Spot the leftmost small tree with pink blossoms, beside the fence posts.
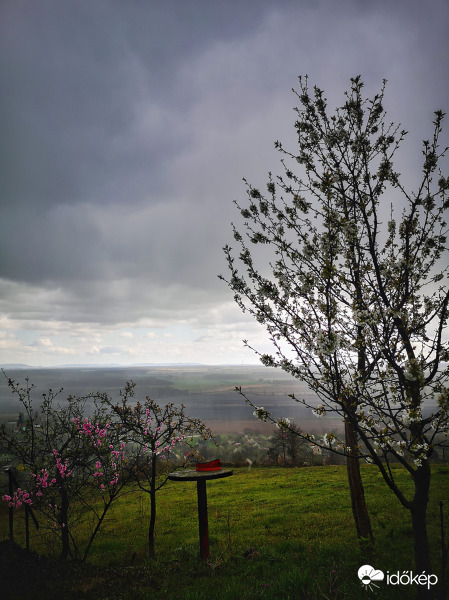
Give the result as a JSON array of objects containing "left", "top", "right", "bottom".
[{"left": 0, "top": 379, "right": 131, "bottom": 560}]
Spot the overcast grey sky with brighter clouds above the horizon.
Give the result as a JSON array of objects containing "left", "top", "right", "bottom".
[{"left": 0, "top": 0, "right": 449, "bottom": 365}]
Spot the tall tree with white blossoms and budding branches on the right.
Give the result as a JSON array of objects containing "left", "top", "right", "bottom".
[{"left": 221, "top": 77, "right": 449, "bottom": 573}]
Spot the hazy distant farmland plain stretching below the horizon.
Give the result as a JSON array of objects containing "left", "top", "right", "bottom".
[{"left": 0, "top": 365, "right": 341, "bottom": 433}]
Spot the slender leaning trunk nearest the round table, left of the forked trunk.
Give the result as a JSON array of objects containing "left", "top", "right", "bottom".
[{"left": 345, "top": 419, "right": 374, "bottom": 545}]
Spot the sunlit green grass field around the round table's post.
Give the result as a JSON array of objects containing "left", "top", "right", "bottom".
[{"left": 0, "top": 465, "right": 449, "bottom": 600}]
